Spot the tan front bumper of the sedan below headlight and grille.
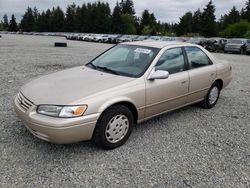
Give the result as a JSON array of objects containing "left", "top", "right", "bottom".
[{"left": 14, "top": 94, "right": 100, "bottom": 144}]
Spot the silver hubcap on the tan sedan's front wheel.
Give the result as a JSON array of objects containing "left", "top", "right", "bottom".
[{"left": 105, "top": 115, "right": 129, "bottom": 143}]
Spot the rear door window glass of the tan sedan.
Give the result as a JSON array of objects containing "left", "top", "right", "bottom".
[{"left": 185, "top": 47, "right": 211, "bottom": 69}]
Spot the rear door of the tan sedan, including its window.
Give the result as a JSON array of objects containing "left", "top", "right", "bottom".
[{"left": 185, "top": 46, "right": 216, "bottom": 103}]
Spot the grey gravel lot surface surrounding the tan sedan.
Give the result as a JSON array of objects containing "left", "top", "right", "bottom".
[{"left": 0, "top": 35, "right": 250, "bottom": 188}]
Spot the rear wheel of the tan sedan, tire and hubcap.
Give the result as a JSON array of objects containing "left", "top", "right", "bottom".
[{"left": 200, "top": 82, "right": 221, "bottom": 109}]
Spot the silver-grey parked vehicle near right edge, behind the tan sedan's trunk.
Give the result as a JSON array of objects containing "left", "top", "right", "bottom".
[{"left": 224, "top": 39, "right": 247, "bottom": 54}]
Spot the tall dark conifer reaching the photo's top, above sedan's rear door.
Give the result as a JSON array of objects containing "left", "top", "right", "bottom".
[{"left": 201, "top": 1, "right": 217, "bottom": 37}]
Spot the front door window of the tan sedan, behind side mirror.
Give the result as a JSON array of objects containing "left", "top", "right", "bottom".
[{"left": 155, "top": 48, "right": 184, "bottom": 74}]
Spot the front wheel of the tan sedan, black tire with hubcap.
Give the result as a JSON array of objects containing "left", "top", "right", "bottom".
[{"left": 93, "top": 105, "right": 134, "bottom": 150}]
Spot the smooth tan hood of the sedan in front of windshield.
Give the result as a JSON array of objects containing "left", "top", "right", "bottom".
[{"left": 20, "top": 66, "right": 135, "bottom": 105}]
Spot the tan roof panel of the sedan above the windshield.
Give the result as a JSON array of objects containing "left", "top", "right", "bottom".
[{"left": 122, "top": 40, "right": 192, "bottom": 49}]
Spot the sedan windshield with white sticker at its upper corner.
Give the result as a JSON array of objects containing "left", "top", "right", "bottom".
[{"left": 86, "top": 44, "right": 159, "bottom": 77}]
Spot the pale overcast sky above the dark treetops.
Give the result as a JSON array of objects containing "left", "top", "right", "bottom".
[{"left": 0, "top": 0, "right": 246, "bottom": 22}]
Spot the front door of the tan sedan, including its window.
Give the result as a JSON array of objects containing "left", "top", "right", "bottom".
[{"left": 146, "top": 47, "right": 189, "bottom": 118}]
